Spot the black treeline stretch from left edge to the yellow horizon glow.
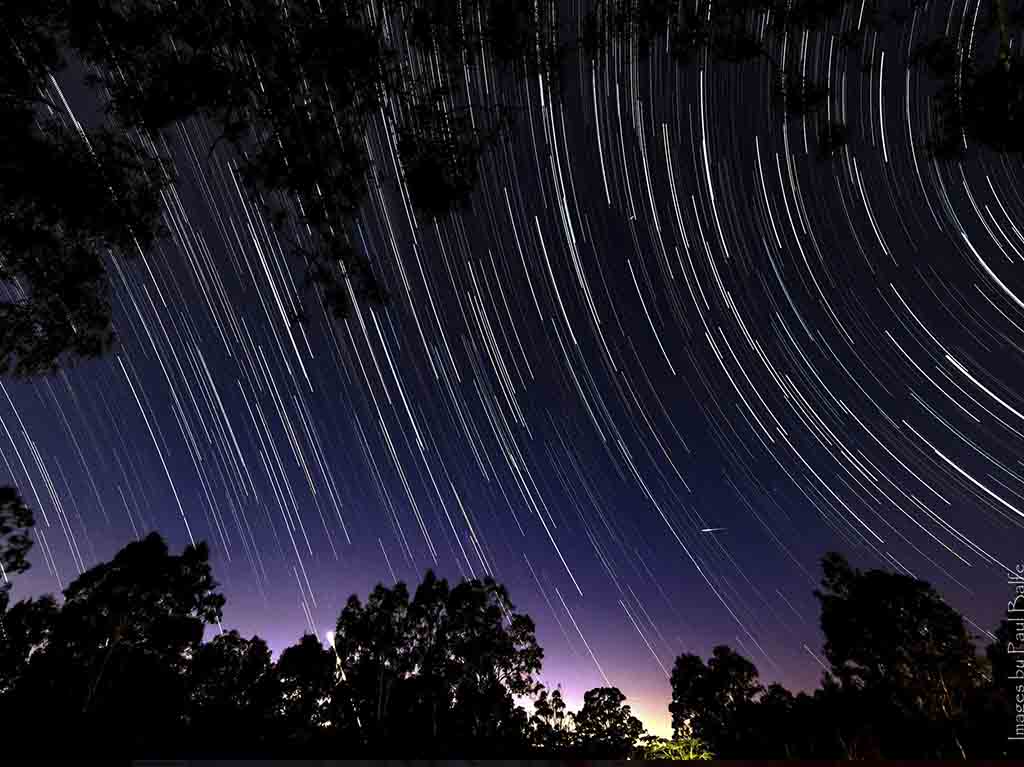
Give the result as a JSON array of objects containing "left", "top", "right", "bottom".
[{"left": 0, "top": 488, "right": 643, "bottom": 757}]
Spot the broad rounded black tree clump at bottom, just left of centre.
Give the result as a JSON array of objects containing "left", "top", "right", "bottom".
[{"left": 334, "top": 571, "right": 543, "bottom": 754}]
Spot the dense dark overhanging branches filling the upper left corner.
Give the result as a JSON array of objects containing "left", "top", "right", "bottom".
[{"left": 0, "top": 0, "right": 559, "bottom": 375}]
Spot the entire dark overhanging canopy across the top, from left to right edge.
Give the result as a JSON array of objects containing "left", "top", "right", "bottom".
[{"left": 8, "top": 0, "right": 1024, "bottom": 376}]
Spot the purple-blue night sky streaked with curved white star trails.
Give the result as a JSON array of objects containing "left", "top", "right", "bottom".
[{"left": 0, "top": 0, "right": 1024, "bottom": 733}]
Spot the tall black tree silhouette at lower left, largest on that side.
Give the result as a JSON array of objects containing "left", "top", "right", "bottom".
[{"left": 4, "top": 534, "right": 224, "bottom": 753}]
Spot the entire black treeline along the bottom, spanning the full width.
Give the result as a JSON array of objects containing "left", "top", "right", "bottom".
[{"left": 0, "top": 488, "right": 1014, "bottom": 759}]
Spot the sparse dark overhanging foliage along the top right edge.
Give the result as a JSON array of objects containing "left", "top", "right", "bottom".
[{"left": 581, "top": 0, "right": 1024, "bottom": 159}]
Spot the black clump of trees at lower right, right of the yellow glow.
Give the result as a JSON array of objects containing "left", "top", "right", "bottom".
[{"left": 670, "top": 554, "right": 1013, "bottom": 759}]
